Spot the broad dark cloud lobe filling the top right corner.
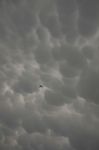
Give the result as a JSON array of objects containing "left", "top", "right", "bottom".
[{"left": 78, "top": 0, "right": 99, "bottom": 37}]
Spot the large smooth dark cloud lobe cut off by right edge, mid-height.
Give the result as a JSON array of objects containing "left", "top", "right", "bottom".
[{"left": 79, "top": 68, "right": 99, "bottom": 103}]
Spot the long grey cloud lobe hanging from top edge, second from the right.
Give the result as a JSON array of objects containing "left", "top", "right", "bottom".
[{"left": 57, "top": 0, "right": 78, "bottom": 42}]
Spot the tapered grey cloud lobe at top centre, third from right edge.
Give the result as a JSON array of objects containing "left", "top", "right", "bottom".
[{"left": 40, "top": 1, "right": 61, "bottom": 38}]
